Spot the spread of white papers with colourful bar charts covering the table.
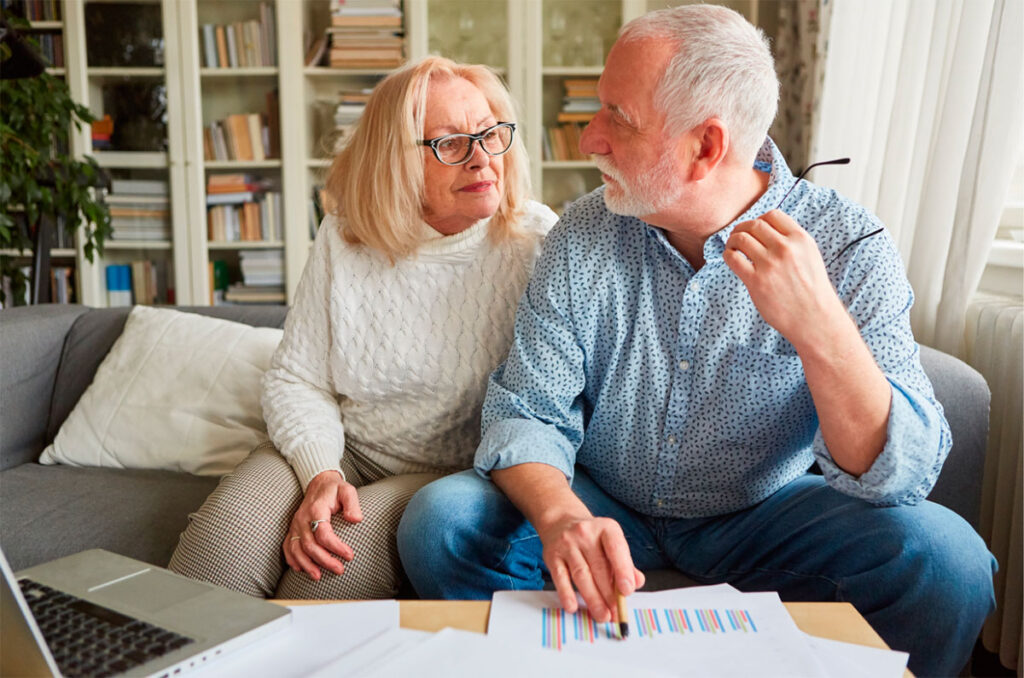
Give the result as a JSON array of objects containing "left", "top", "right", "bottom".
[{"left": 188, "top": 585, "right": 907, "bottom": 678}]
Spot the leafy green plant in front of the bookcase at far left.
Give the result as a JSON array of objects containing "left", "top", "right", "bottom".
[{"left": 0, "top": 16, "right": 111, "bottom": 305}]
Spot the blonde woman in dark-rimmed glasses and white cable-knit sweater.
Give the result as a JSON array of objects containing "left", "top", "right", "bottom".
[{"left": 170, "top": 57, "right": 556, "bottom": 598}]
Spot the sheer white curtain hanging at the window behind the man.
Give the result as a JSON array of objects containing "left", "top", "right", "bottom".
[{"left": 810, "top": 0, "right": 1024, "bottom": 355}]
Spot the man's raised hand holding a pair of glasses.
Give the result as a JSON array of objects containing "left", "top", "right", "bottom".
[{"left": 722, "top": 210, "right": 849, "bottom": 350}]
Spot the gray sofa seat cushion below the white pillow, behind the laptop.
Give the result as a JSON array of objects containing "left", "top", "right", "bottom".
[{"left": 0, "top": 464, "right": 219, "bottom": 570}]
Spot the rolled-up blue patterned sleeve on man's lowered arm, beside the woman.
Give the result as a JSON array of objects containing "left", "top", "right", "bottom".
[{"left": 473, "top": 224, "right": 585, "bottom": 480}]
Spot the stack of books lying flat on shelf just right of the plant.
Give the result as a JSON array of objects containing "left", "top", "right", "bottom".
[{"left": 105, "top": 179, "right": 171, "bottom": 242}]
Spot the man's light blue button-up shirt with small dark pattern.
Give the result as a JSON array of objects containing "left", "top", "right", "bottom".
[{"left": 474, "top": 139, "right": 951, "bottom": 517}]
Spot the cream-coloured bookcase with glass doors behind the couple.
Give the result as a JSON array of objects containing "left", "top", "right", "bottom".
[{"left": 8, "top": 0, "right": 759, "bottom": 306}]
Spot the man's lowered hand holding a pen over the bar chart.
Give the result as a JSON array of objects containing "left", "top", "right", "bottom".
[{"left": 538, "top": 517, "right": 644, "bottom": 623}]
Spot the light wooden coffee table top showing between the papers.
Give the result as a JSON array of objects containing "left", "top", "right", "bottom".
[{"left": 273, "top": 600, "right": 913, "bottom": 678}]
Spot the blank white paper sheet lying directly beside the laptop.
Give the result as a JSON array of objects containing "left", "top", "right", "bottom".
[{"left": 188, "top": 600, "right": 398, "bottom": 678}]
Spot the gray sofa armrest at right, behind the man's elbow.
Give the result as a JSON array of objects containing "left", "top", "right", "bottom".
[{"left": 921, "top": 346, "right": 991, "bottom": 529}]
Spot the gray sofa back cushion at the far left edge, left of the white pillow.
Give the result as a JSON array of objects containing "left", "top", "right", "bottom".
[{"left": 0, "top": 304, "right": 88, "bottom": 470}]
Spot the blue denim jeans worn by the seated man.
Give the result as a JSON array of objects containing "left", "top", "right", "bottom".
[{"left": 398, "top": 468, "right": 995, "bottom": 677}]
